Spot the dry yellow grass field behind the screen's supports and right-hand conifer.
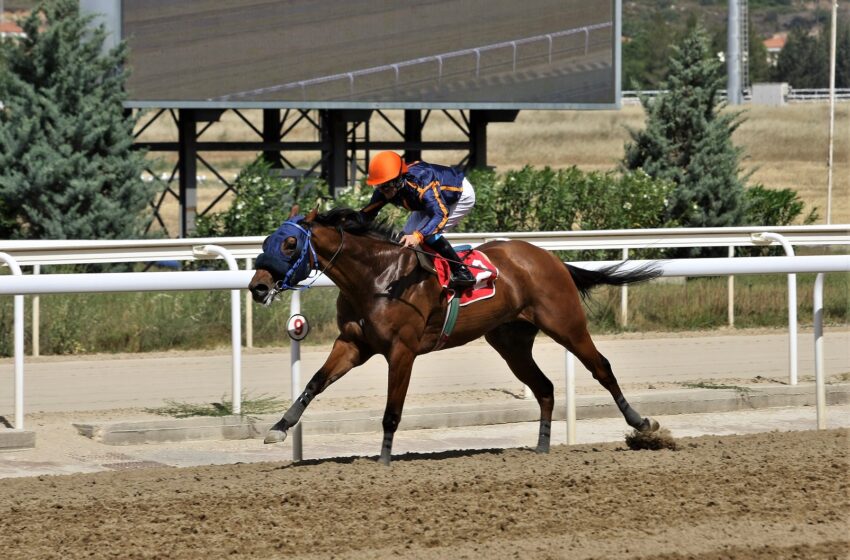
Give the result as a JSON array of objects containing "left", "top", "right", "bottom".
[{"left": 142, "top": 103, "right": 850, "bottom": 231}]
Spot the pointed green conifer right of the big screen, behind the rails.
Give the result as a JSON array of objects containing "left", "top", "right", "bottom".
[{"left": 622, "top": 26, "right": 744, "bottom": 240}]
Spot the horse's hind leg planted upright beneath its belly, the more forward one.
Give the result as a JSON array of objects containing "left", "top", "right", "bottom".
[{"left": 484, "top": 321, "right": 555, "bottom": 453}]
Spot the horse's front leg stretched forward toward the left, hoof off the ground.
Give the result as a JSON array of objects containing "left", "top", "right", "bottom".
[{"left": 264, "top": 338, "right": 372, "bottom": 443}]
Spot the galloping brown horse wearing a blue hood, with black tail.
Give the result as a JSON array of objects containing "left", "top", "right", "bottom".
[{"left": 249, "top": 208, "right": 659, "bottom": 464}]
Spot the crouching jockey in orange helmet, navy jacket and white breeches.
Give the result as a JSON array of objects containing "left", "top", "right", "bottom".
[{"left": 361, "top": 152, "right": 475, "bottom": 290}]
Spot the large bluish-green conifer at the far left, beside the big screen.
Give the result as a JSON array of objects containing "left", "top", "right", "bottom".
[{"left": 0, "top": 0, "right": 153, "bottom": 239}]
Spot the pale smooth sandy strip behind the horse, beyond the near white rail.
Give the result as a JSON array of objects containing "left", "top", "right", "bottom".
[{"left": 0, "top": 326, "right": 850, "bottom": 414}]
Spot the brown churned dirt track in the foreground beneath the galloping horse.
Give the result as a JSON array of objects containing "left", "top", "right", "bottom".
[{"left": 0, "top": 429, "right": 850, "bottom": 560}]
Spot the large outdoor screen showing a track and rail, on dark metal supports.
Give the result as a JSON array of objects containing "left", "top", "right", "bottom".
[{"left": 106, "top": 0, "right": 621, "bottom": 109}]
